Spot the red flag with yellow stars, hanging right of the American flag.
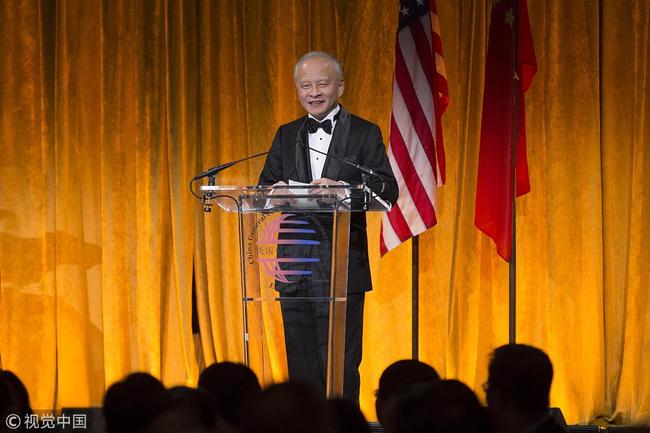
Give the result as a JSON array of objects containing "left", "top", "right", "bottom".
[{"left": 474, "top": 0, "right": 537, "bottom": 261}]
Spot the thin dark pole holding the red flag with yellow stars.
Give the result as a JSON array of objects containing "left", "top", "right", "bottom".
[{"left": 508, "top": 0, "right": 520, "bottom": 344}]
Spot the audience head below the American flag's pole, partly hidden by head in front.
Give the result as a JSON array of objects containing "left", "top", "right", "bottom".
[{"left": 375, "top": 359, "right": 440, "bottom": 433}]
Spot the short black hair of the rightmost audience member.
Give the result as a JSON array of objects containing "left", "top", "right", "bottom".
[{"left": 487, "top": 344, "right": 553, "bottom": 414}]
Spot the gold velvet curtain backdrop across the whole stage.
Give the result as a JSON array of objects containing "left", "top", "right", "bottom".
[{"left": 0, "top": 0, "right": 650, "bottom": 423}]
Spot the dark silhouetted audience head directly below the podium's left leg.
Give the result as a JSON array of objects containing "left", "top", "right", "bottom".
[{"left": 199, "top": 362, "right": 262, "bottom": 427}]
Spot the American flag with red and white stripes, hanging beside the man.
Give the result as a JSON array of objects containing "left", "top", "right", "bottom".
[{"left": 380, "top": 0, "right": 449, "bottom": 256}]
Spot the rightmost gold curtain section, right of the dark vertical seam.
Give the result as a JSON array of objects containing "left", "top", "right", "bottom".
[{"left": 600, "top": 1, "right": 650, "bottom": 421}]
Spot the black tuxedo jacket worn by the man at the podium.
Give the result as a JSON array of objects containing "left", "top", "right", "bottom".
[{"left": 259, "top": 107, "right": 398, "bottom": 293}]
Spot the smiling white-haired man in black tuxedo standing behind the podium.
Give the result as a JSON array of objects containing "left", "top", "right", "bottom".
[{"left": 259, "top": 51, "right": 398, "bottom": 402}]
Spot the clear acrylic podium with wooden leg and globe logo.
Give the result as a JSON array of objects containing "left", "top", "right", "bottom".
[{"left": 201, "top": 185, "right": 390, "bottom": 397}]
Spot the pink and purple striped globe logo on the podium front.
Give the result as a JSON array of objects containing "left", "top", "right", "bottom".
[{"left": 258, "top": 214, "right": 320, "bottom": 283}]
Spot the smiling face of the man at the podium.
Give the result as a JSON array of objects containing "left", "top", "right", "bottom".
[{"left": 296, "top": 57, "right": 344, "bottom": 119}]
